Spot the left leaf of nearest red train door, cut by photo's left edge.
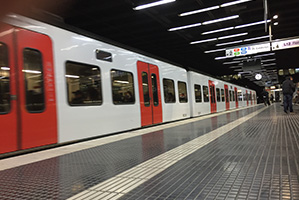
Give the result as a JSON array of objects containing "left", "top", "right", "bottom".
[{"left": 0, "top": 24, "right": 18, "bottom": 153}]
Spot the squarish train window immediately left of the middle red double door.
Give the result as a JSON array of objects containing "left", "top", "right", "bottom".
[{"left": 111, "top": 69, "right": 135, "bottom": 105}]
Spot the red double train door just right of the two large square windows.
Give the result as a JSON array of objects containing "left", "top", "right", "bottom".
[{"left": 137, "top": 61, "right": 162, "bottom": 126}]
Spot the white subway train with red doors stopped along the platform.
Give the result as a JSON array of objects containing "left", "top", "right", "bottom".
[{"left": 0, "top": 14, "right": 256, "bottom": 155}]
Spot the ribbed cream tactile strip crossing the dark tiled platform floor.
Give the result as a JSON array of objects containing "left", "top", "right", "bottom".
[{"left": 68, "top": 107, "right": 267, "bottom": 200}]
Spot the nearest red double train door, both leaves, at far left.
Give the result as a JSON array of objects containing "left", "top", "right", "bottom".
[{"left": 0, "top": 26, "right": 57, "bottom": 153}]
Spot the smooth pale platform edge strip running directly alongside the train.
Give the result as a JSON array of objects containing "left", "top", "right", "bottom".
[{"left": 0, "top": 105, "right": 259, "bottom": 171}]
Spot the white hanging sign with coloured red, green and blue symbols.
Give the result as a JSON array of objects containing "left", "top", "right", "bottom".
[{"left": 226, "top": 43, "right": 271, "bottom": 57}]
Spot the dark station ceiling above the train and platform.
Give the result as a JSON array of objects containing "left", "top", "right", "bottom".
[{"left": 11, "top": 0, "right": 299, "bottom": 86}]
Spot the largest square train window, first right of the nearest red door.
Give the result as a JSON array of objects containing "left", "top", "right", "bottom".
[{"left": 65, "top": 61, "right": 103, "bottom": 106}]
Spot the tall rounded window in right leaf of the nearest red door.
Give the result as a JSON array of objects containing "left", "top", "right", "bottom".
[{"left": 22, "top": 48, "right": 46, "bottom": 112}]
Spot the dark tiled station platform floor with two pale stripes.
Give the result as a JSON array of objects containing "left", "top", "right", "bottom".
[{"left": 0, "top": 103, "right": 299, "bottom": 200}]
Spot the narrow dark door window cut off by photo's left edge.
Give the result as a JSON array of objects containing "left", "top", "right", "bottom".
[{"left": 0, "top": 43, "right": 11, "bottom": 114}]
